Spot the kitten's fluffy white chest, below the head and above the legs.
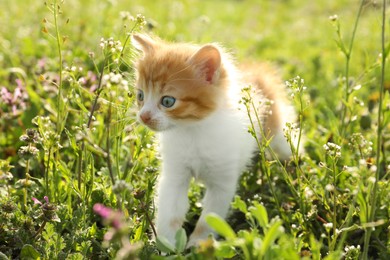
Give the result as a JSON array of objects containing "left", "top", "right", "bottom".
[{"left": 160, "top": 107, "right": 256, "bottom": 182}]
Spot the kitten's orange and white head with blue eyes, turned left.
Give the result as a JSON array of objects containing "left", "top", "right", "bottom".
[{"left": 133, "top": 34, "right": 226, "bottom": 131}]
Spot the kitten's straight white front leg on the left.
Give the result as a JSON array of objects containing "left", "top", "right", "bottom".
[{"left": 156, "top": 168, "right": 190, "bottom": 245}]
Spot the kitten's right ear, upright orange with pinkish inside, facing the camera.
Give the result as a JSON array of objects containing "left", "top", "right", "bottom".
[{"left": 190, "top": 44, "right": 221, "bottom": 83}]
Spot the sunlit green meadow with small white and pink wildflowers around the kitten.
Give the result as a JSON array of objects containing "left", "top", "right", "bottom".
[{"left": 0, "top": 0, "right": 390, "bottom": 259}]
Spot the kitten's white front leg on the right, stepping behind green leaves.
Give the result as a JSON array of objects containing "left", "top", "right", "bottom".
[{"left": 187, "top": 172, "right": 238, "bottom": 247}]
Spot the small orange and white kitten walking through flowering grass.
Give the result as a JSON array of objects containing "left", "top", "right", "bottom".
[{"left": 133, "top": 34, "right": 295, "bottom": 246}]
